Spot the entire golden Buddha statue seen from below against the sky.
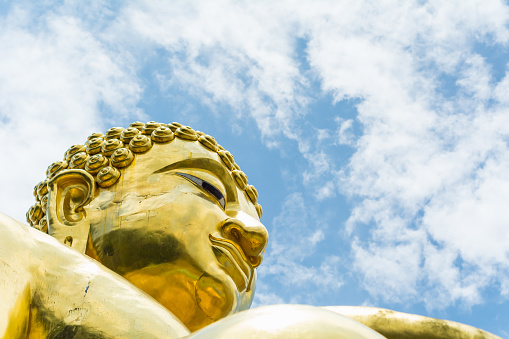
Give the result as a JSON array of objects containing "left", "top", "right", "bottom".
[{"left": 0, "top": 122, "right": 497, "bottom": 338}]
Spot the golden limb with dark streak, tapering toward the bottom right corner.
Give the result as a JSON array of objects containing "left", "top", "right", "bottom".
[{"left": 324, "top": 306, "right": 501, "bottom": 339}]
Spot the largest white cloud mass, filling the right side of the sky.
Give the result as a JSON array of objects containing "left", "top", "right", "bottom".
[{"left": 328, "top": 1, "right": 509, "bottom": 308}]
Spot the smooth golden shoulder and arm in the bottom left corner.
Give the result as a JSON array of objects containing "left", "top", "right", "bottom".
[{"left": 0, "top": 214, "right": 189, "bottom": 338}]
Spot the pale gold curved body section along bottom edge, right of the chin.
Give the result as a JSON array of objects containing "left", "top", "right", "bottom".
[{"left": 186, "top": 305, "right": 500, "bottom": 339}]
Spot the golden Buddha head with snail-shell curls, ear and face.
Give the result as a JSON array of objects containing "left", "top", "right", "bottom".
[{"left": 27, "top": 122, "right": 268, "bottom": 331}]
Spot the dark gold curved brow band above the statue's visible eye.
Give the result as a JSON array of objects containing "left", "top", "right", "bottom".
[{"left": 153, "top": 158, "right": 238, "bottom": 203}]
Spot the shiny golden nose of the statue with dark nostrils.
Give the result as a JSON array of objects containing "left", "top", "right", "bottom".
[{"left": 221, "top": 211, "right": 269, "bottom": 268}]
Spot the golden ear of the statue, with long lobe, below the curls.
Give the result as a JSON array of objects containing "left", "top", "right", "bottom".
[{"left": 46, "top": 169, "right": 95, "bottom": 253}]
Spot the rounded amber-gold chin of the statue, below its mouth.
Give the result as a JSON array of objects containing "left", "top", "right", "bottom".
[{"left": 195, "top": 273, "right": 239, "bottom": 321}]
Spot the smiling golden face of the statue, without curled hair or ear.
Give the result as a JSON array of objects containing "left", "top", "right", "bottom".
[{"left": 81, "top": 139, "right": 268, "bottom": 331}]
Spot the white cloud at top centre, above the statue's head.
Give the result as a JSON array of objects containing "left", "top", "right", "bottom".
[{"left": 112, "top": 1, "right": 308, "bottom": 143}]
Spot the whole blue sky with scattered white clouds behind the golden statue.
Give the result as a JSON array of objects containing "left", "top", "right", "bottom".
[{"left": 0, "top": 0, "right": 509, "bottom": 338}]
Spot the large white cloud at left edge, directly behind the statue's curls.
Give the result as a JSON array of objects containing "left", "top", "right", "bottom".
[{"left": 0, "top": 9, "right": 140, "bottom": 221}]
